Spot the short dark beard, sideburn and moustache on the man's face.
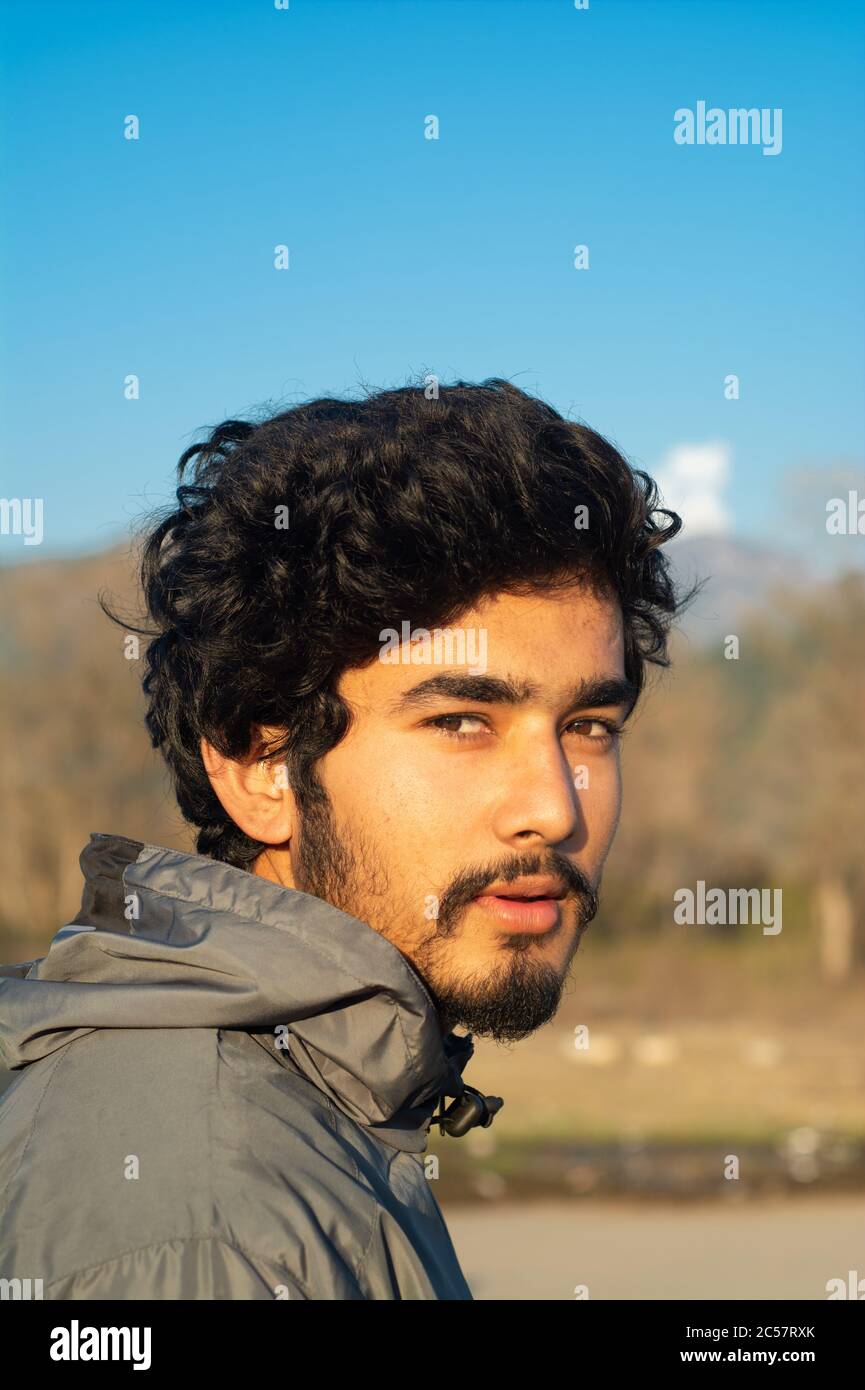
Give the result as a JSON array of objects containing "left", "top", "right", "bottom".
[{"left": 295, "top": 776, "right": 598, "bottom": 1043}]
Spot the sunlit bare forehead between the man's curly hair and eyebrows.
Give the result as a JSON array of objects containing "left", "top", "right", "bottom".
[{"left": 339, "top": 584, "right": 624, "bottom": 708}]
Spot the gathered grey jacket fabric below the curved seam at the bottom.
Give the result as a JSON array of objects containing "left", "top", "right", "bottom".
[{"left": 45, "top": 1236, "right": 314, "bottom": 1301}]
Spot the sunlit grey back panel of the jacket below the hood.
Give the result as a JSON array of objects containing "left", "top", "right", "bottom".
[{"left": 0, "top": 1029, "right": 375, "bottom": 1298}]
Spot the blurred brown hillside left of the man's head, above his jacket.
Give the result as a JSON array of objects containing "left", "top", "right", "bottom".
[{"left": 0, "top": 545, "right": 189, "bottom": 937}]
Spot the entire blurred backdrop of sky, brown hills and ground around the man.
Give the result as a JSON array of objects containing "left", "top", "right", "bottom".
[{"left": 0, "top": 0, "right": 865, "bottom": 1298}]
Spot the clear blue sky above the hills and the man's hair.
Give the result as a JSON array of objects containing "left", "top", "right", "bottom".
[{"left": 0, "top": 0, "right": 865, "bottom": 560}]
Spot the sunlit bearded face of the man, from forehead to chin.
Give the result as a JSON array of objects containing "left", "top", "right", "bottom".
[{"left": 280, "top": 584, "right": 634, "bottom": 1040}]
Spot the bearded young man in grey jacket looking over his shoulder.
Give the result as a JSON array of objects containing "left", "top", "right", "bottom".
[{"left": 0, "top": 379, "right": 680, "bottom": 1300}]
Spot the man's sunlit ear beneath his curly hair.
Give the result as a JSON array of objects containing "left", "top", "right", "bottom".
[{"left": 199, "top": 726, "right": 298, "bottom": 845}]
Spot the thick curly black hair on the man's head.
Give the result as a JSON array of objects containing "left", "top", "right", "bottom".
[{"left": 100, "top": 378, "right": 687, "bottom": 869}]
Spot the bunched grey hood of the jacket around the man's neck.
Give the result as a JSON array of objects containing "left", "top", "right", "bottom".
[{"left": 0, "top": 834, "right": 474, "bottom": 1152}]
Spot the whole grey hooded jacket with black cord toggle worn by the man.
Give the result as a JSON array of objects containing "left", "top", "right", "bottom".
[{"left": 0, "top": 834, "right": 488, "bottom": 1300}]
